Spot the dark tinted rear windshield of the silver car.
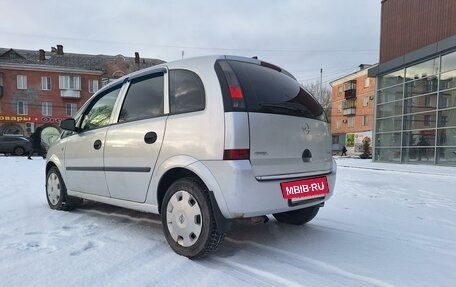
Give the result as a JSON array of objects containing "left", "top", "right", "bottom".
[{"left": 218, "top": 61, "right": 327, "bottom": 121}]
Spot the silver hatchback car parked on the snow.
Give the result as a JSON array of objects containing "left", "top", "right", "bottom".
[{"left": 46, "top": 56, "right": 336, "bottom": 258}]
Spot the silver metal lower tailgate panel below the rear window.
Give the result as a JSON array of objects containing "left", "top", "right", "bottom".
[{"left": 249, "top": 113, "right": 332, "bottom": 177}]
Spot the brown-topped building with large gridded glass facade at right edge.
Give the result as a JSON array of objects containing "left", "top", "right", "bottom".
[{"left": 369, "top": 0, "right": 456, "bottom": 166}]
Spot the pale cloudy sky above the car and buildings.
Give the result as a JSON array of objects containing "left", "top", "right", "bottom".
[{"left": 0, "top": 0, "right": 381, "bottom": 85}]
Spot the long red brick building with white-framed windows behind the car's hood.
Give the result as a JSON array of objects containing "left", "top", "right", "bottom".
[{"left": 0, "top": 45, "right": 163, "bottom": 146}]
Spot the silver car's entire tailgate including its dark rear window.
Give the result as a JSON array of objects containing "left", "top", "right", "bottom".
[{"left": 224, "top": 61, "right": 332, "bottom": 179}]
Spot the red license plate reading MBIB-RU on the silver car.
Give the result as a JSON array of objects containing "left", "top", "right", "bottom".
[{"left": 280, "top": 176, "right": 329, "bottom": 200}]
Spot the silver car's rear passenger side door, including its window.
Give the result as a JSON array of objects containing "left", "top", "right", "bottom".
[{"left": 104, "top": 69, "right": 167, "bottom": 202}]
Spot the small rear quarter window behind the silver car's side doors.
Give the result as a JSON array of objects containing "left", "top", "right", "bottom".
[{"left": 169, "top": 70, "right": 205, "bottom": 114}]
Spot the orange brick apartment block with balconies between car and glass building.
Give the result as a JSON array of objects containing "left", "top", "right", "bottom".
[{"left": 330, "top": 65, "right": 375, "bottom": 155}]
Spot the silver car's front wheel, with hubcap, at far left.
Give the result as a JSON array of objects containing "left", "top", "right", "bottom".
[{"left": 46, "top": 166, "right": 74, "bottom": 211}]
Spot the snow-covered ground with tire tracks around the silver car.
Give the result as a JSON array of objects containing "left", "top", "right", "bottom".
[{"left": 0, "top": 156, "right": 456, "bottom": 287}]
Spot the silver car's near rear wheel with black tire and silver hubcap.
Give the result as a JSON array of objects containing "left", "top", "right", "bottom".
[{"left": 161, "top": 178, "right": 224, "bottom": 259}]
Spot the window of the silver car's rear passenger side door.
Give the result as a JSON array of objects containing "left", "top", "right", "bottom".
[{"left": 119, "top": 73, "right": 164, "bottom": 122}]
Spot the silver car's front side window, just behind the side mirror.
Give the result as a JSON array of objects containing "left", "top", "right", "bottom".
[{"left": 81, "top": 86, "right": 122, "bottom": 131}]
